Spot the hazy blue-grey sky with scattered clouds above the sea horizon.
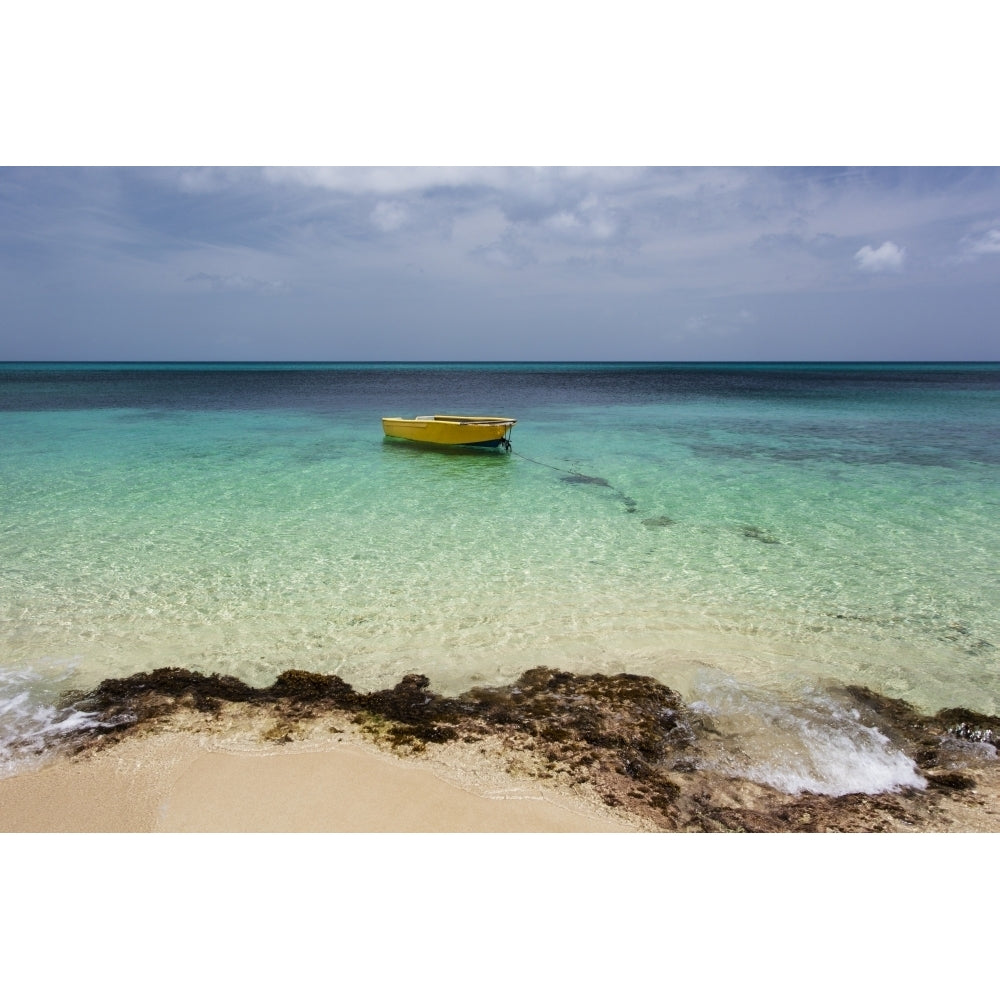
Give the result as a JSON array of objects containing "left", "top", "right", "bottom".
[{"left": 0, "top": 166, "right": 1000, "bottom": 360}]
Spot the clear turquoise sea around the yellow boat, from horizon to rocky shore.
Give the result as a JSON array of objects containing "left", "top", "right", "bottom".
[{"left": 0, "top": 364, "right": 1000, "bottom": 794}]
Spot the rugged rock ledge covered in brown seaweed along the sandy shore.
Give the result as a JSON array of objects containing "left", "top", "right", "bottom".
[{"left": 56, "top": 667, "right": 1000, "bottom": 832}]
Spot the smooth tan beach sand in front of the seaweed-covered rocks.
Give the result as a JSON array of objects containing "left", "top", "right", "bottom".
[{"left": 0, "top": 704, "right": 643, "bottom": 833}]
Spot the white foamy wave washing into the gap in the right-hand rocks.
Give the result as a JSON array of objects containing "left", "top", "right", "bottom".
[{"left": 691, "top": 671, "right": 927, "bottom": 796}]
